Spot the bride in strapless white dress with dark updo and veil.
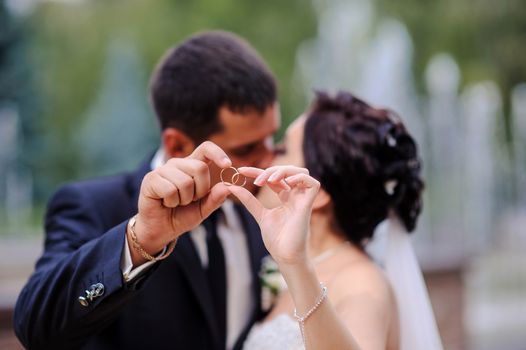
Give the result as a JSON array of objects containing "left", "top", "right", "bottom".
[{"left": 229, "top": 92, "right": 441, "bottom": 350}]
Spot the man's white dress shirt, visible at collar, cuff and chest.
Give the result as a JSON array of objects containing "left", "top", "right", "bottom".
[{"left": 121, "top": 149, "right": 256, "bottom": 349}]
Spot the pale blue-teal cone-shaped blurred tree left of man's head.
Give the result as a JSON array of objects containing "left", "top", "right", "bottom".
[{"left": 75, "top": 39, "right": 159, "bottom": 177}]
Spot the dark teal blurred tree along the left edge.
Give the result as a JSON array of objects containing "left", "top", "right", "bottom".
[{"left": 0, "top": 0, "right": 42, "bottom": 219}]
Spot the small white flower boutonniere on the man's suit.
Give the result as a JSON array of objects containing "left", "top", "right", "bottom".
[{"left": 259, "top": 255, "right": 287, "bottom": 311}]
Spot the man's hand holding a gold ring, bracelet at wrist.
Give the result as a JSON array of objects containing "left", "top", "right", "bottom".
[{"left": 128, "top": 141, "right": 232, "bottom": 266}]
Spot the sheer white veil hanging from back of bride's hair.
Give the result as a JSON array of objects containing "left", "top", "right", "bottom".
[{"left": 366, "top": 215, "right": 443, "bottom": 350}]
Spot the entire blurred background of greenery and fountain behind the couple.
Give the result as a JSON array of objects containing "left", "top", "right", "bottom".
[{"left": 0, "top": 0, "right": 526, "bottom": 349}]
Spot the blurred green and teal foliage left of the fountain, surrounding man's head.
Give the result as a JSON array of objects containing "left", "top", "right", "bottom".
[{"left": 0, "top": 0, "right": 316, "bottom": 208}]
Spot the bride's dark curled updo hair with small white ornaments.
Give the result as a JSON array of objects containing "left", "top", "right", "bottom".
[{"left": 303, "top": 92, "right": 424, "bottom": 246}]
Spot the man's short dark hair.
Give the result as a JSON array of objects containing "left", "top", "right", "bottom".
[{"left": 151, "top": 31, "right": 276, "bottom": 142}]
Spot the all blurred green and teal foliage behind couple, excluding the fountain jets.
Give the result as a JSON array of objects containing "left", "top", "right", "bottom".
[{"left": 0, "top": 0, "right": 526, "bottom": 208}]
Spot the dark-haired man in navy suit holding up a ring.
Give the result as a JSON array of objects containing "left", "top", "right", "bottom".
[{"left": 14, "top": 32, "right": 279, "bottom": 350}]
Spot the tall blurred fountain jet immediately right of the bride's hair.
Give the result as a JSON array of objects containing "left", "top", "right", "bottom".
[{"left": 422, "top": 53, "right": 464, "bottom": 264}]
